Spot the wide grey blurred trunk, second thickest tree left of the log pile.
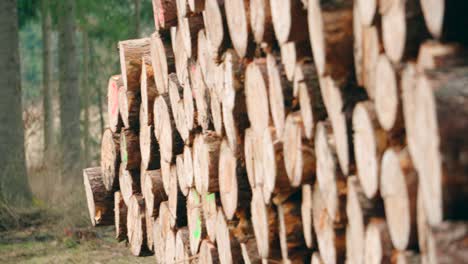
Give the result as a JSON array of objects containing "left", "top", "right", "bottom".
[{"left": 58, "top": 0, "right": 81, "bottom": 180}]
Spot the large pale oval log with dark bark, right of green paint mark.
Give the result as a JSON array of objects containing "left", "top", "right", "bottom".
[{"left": 218, "top": 140, "right": 251, "bottom": 220}]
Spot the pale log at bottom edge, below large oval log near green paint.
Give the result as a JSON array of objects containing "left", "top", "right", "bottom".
[{"left": 216, "top": 209, "right": 242, "bottom": 264}]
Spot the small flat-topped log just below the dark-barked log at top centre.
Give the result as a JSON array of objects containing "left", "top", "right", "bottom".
[{"left": 281, "top": 40, "right": 312, "bottom": 81}]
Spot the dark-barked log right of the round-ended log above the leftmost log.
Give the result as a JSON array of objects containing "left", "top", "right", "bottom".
[{"left": 120, "top": 129, "right": 141, "bottom": 170}]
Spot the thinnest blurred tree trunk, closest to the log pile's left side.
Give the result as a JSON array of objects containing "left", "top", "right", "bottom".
[{"left": 82, "top": 29, "right": 91, "bottom": 165}]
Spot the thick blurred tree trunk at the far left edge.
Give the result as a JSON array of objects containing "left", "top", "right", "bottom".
[{"left": 0, "top": 0, "right": 31, "bottom": 204}]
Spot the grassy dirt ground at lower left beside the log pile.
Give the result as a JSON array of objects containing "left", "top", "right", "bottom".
[{"left": 0, "top": 225, "right": 155, "bottom": 264}]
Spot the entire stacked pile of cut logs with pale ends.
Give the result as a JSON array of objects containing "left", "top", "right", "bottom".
[{"left": 84, "top": 0, "right": 468, "bottom": 264}]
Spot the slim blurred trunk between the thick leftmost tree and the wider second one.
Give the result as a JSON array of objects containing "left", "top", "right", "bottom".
[{"left": 41, "top": 0, "right": 55, "bottom": 164}]
